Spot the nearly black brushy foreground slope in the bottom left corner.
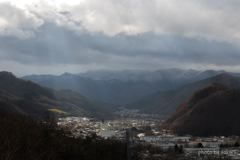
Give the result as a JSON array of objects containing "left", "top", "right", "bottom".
[{"left": 0, "top": 107, "right": 125, "bottom": 160}]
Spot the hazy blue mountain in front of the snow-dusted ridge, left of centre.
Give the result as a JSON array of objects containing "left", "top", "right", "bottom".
[{"left": 22, "top": 73, "right": 157, "bottom": 105}]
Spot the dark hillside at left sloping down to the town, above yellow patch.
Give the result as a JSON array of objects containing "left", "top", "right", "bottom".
[{"left": 0, "top": 72, "right": 112, "bottom": 119}]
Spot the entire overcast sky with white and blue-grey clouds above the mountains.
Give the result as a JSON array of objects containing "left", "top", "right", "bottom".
[{"left": 0, "top": 0, "right": 240, "bottom": 76}]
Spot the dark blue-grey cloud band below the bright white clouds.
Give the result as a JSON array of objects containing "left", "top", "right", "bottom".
[{"left": 0, "top": 23, "right": 240, "bottom": 66}]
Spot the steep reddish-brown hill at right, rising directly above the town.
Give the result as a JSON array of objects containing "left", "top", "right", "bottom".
[{"left": 161, "top": 83, "right": 240, "bottom": 136}]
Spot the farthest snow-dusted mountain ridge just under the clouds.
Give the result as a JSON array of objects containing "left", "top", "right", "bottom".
[{"left": 78, "top": 68, "right": 240, "bottom": 84}]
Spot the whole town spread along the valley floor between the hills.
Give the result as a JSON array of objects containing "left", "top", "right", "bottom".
[{"left": 57, "top": 107, "right": 240, "bottom": 159}]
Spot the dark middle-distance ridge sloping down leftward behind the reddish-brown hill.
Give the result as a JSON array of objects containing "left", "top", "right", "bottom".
[{"left": 126, "top": 73, "right": 240, "bottom": 115}]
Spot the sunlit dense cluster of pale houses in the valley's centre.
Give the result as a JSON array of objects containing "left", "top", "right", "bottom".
[{"left": 57, "top": 117, "right": 160, "bottom": 138}]
